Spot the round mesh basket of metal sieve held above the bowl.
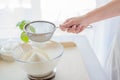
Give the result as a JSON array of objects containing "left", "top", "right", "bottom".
[{"left": 24, "top": 21, "right": 57, "bottom": 42}]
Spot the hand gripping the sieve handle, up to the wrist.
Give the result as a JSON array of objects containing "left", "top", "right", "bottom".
[{"left": 60, "top": 16, "right": 89, "bottom": 33}]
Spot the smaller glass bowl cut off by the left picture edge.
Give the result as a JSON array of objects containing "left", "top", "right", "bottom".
[{"left": 0, "top": 39, "right": 20, "bottom": 62}]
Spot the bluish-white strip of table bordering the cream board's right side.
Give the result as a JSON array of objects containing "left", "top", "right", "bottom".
[{"left": 52, "top": 35, "right": 108, "bottom": 80}]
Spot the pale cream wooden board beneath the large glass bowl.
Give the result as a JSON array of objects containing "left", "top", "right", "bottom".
[{"left": 0, "top": 47, "right": 90, "bottom": 80}]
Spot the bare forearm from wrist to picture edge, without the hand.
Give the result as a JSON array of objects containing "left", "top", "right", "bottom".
[{"left": 85, "top": 0, "right": 120, "bottom": 23}]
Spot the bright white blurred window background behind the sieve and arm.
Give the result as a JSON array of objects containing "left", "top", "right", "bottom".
[{"left": 0, "top": 0, "right": 96, "bottom": 41}]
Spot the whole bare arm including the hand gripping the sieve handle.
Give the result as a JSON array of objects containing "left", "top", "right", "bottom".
[{"left": 60, "top": 0, "right": 120, "bottom": 33}]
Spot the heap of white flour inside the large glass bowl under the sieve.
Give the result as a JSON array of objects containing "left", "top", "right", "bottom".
[{"left": 17, "top": 44, "right": 58, "bottom": 77}]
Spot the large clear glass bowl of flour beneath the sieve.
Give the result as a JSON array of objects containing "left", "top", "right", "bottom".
[{"left": 13, "top": 41, "right": 63, "bottom": 80}]
